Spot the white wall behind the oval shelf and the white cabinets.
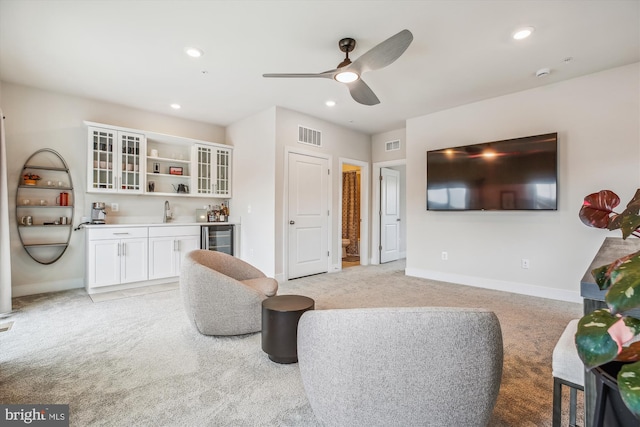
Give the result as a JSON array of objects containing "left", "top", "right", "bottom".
[{"left": 0, "top": 82, "right": 226, "bottom": 296}]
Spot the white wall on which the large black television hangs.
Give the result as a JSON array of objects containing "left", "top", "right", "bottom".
[{"left": 406, "top": 63, "right": 640, "bottom": 302}]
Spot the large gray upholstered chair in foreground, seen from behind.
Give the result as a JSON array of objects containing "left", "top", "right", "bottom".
[{"left": 298, "top": 307, "right": 503, "bottom": 427}]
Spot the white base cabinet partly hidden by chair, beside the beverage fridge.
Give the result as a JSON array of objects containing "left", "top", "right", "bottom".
[{"left": 149, "top": 225, "right": 200, "bottom": 280}]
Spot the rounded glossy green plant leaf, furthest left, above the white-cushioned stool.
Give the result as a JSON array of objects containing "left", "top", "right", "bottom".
[{"left": 575, "top": 309, "right": 620, "bottom": 369}]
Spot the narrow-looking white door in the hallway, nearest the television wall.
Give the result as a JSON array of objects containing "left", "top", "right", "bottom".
[{"left": 380, "top": 168, "right": 400, "bottom": 263}]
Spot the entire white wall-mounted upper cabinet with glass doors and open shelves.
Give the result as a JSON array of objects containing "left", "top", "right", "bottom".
[{"left": 85, "top": 122, "right": 233, "bottom": 198}]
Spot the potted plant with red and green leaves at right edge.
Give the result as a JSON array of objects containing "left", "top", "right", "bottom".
[{"left": 576, "top": 189, "right": 640, "bottom": 419}]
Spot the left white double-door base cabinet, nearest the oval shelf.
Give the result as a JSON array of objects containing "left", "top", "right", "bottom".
[{"left": 87, "top": 227, "right": 148, "bottom": 288}]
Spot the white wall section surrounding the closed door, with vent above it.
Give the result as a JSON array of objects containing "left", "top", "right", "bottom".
[{"left": 275, "top": 107, "right": 371, "bottom": 278}]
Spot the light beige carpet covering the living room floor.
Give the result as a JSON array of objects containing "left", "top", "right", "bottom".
[{"left": 0, "top": 261, "right": 582, "bottom": 427}]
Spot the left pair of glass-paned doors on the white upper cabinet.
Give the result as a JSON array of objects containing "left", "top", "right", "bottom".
[{"left": 87, "top": 127, "right": 145, "bottom": 193}]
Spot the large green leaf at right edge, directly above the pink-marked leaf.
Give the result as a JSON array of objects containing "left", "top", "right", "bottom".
[{"left": 596, "top": 251, "right": 640, "bottom": 314}]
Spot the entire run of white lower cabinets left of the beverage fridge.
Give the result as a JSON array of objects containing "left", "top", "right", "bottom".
[{"left": 85, "top": 225, "right": 200, "bottom": 293}]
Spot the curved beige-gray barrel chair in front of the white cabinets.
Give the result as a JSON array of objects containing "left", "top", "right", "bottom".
[{"left": 180, "top": 250, "right": 278, "bottom": 335}]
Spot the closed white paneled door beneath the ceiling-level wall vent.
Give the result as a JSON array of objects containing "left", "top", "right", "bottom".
[{"left": 287, "top": 153, "right": 329, "bottom": 279}]
